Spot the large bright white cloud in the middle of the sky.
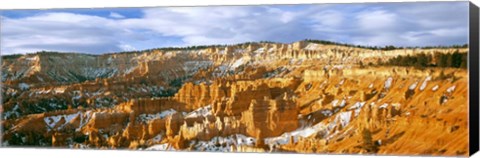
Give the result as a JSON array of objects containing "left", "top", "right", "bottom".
[{"left": 122, "top": 7, "right": 304, "bottom": 45}]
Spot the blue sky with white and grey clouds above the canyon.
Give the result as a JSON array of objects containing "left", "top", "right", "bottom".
[{"left": 0, "top": 2, "right": 468, "bottom": 55}]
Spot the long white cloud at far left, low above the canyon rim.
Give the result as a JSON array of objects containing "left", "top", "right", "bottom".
[{"left": 1, "top": 13, "right": 127, "bottom": 54}]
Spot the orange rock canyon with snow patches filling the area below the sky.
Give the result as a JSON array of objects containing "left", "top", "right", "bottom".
[{"left": 2, "top": 41, "right": 468, "bottom": 156}]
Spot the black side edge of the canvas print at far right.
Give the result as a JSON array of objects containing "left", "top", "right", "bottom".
[{"left": 468, "top": 2, "right": 480, "bottom": 156}]
